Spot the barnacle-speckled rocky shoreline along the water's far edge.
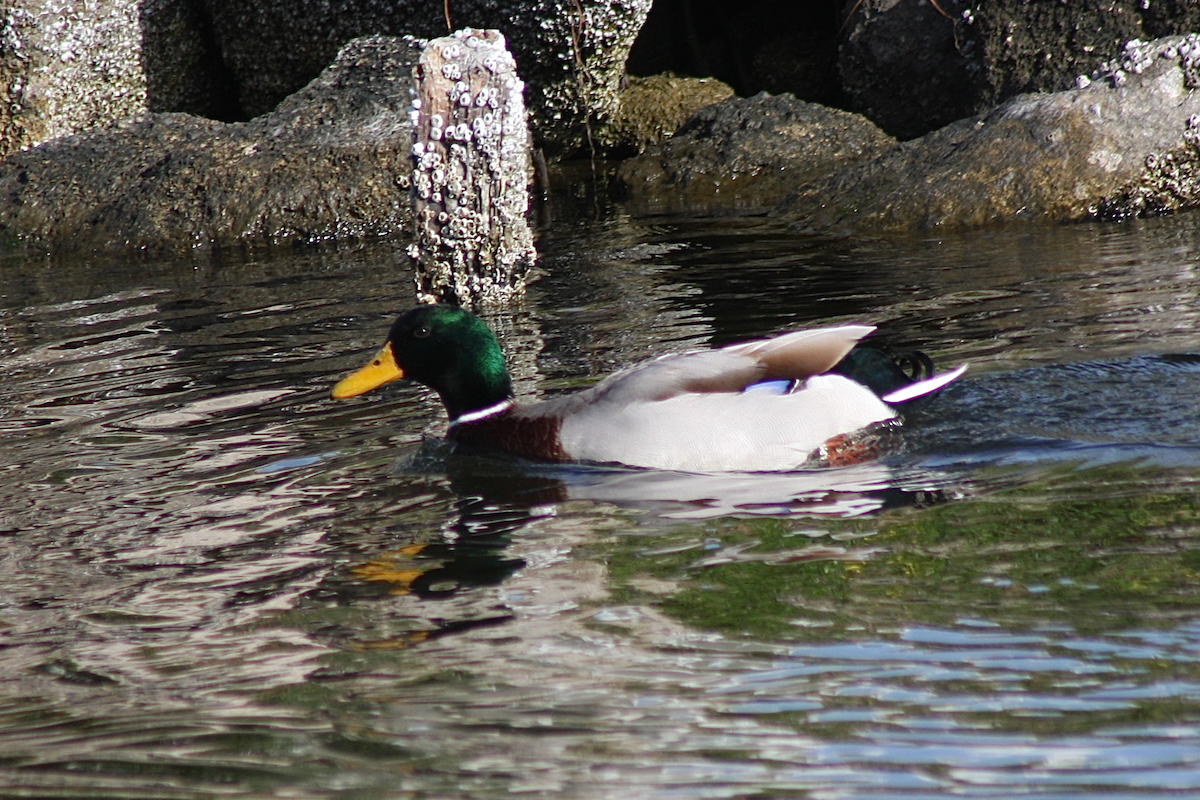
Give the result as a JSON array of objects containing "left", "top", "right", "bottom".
[{"left": 7, "top": 0, "right": 1200, "bottom": 252}]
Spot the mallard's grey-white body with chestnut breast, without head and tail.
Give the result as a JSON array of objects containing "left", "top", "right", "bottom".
[{"left": 452, "top": 325, "right": 953, "bottom": 473}]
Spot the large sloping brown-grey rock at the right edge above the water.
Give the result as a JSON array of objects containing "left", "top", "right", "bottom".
[{"left": 779, "top": 35, "right": 1200, "bottom": 231}]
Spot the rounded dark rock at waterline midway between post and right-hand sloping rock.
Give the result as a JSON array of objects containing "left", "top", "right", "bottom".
[{"left": 617, "top": 94, "right": 895, "bottom": 212}]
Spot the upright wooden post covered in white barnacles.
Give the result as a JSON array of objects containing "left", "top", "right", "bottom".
[{"left": 409, "top": 28, "right": 536, "bottom": 307}]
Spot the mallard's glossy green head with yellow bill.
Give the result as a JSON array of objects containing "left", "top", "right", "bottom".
[{"left": 334, "top": 306, "right": 512, "bottom": 420}]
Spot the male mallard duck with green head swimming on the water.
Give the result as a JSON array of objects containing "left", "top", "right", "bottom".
[{"left": 332, "top": 305, "right": 966, "bottom": 473}]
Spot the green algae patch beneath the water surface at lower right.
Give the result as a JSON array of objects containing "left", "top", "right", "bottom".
[{"left": 607, "top": 465, "right": 1200, "bottom": 639}]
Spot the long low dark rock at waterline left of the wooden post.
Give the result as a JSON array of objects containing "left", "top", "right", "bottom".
[{"left": 0, "top": 37, "right": 420, "bottom": 251}]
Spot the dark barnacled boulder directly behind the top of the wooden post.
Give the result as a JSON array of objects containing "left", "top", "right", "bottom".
[{"left": 188, "top": 0, "right": 650, "bottom": 150}]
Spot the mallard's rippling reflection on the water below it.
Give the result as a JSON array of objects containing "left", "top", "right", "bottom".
[{"left": 345, "top": 441, "right": 956, "bottom": 606}]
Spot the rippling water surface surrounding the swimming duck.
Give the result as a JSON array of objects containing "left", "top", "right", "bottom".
[{"left": 0, "top": 209, "right": 1200, "bottom": 799}]
